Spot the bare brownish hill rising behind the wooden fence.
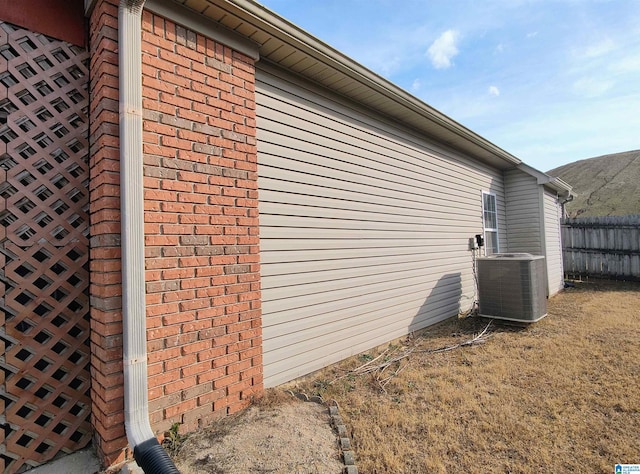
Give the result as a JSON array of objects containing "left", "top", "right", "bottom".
[{"left": 547, "top": 150, "right": 640, "bottom": 217}]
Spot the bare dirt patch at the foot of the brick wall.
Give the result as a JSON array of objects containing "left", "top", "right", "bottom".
[{"left": 175, "top": 391, "right": 344, "bottom": 474}]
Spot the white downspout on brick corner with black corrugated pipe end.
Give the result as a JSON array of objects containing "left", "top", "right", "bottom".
[{"left": 118, "top": 0, "right": 180, "bottom": 474}]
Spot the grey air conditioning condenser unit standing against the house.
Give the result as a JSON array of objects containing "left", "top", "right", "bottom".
[{"left": 476, "top": 253, "right": 547, "bottom": 323}]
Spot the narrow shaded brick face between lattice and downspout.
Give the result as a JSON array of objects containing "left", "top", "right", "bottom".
[{"left": 89, "top": 0, "right": 129, "bottom": 466}]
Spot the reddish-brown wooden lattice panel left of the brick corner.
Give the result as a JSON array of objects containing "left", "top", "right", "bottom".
[{"left": 0, "top": 22, "right": 91, "bottom": 473}]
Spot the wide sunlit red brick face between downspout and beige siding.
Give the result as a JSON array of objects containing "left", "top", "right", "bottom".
[{"left": 142, "top": 12, "right": 262, "bottom": 431}]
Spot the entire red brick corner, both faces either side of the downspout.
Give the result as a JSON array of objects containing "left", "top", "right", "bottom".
[{"left": 90, "top": 0, "right": 262, "bottom": 465}]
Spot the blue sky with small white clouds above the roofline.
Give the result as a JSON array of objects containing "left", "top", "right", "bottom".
[{"left": 259, "top": 0, "right": 640, "bottom": 171}]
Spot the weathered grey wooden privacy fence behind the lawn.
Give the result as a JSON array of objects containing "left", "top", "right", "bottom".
[{"left": 562, "top": 215, "right": 640, "bottom": 280}]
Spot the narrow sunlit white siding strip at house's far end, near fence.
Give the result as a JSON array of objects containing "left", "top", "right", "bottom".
[{"left": 544, "top": 191, "right": 564, "bottom": 296}]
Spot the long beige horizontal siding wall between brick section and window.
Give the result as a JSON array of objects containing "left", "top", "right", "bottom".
[{"left": 256, "top": 64, "right": 505, "bottom": 386}]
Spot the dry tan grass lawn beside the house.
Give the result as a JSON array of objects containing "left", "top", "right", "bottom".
[{"left": 286, "top": 281, "right": 640, "bottom": 474}]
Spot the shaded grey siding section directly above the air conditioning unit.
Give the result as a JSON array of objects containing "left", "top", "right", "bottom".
[{"left": 504, "top": 169, "right": 544, "bottom": 255}]
